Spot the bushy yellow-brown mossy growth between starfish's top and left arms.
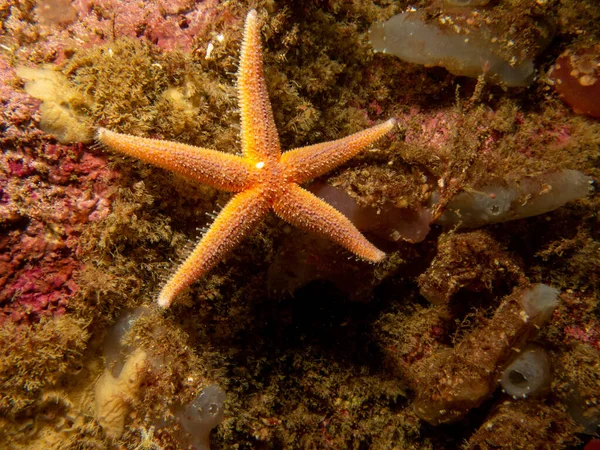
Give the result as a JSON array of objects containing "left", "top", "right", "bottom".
[{"left": 63, "top": 39, "right": 237, "bottom": 150}]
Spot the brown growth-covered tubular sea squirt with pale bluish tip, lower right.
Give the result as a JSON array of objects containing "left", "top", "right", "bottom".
[{"left": 413, "top": 284, "right": 559, "bottom": 425}]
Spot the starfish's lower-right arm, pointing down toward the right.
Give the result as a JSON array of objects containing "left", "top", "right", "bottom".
[{"left": 273, "top": 183, "right": 385, "bottom": 262}]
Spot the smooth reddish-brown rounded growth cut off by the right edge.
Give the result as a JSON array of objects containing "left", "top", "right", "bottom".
[{"left": 548, "top": 45, "right": 600, "bottom": 119}]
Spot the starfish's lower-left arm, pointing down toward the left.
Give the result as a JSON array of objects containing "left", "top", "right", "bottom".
[{"left": 158, "top": 188, "right": 269, "bottom": 308}]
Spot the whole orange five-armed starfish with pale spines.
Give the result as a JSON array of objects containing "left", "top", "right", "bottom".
[{"left": 97, "top": 10, "right": 396, "bottom": 308}]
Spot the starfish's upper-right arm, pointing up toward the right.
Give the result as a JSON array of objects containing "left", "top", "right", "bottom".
[{"left": 281, "top": 119, "right": 396, "bottom": 183}]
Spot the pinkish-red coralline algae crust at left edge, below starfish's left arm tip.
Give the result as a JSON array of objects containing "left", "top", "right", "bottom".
[{"left": 0, "top": 144, "right": 116, "bottom": 321}]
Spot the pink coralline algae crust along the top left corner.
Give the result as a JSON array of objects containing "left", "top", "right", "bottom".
[{"left": 3, "top": 0, "right": 219, "bottom": 62}]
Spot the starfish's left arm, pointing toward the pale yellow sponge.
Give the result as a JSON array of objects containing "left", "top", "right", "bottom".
[{"left": 96, "top": 128, "right": 254, "bottom": 192}]
